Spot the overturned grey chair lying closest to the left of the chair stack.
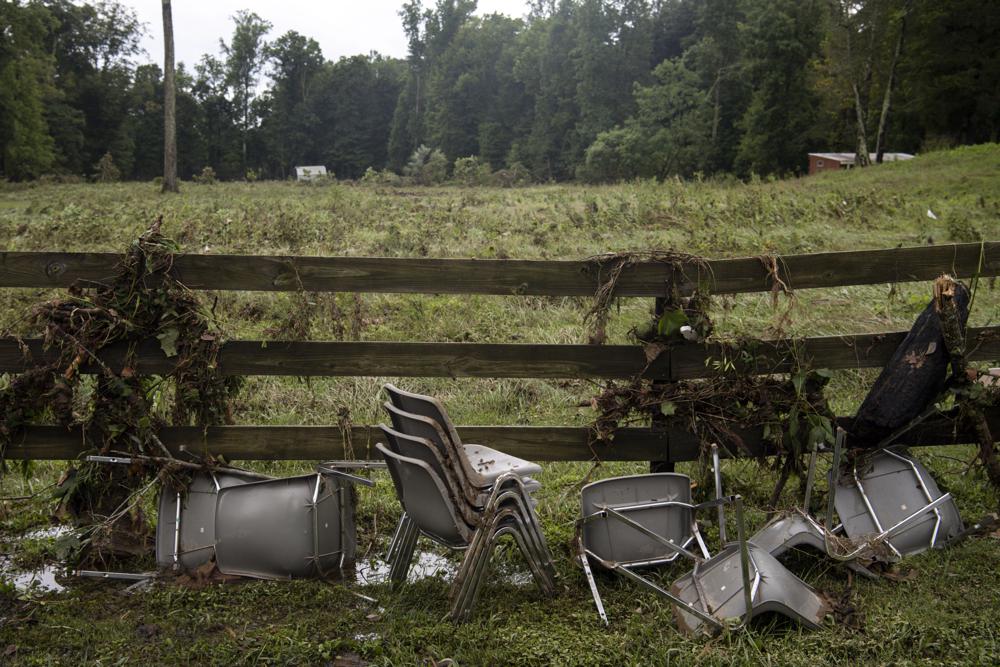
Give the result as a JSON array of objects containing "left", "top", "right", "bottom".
[{"left": 215, "top": 464, "right": 374, "bottom": 579}]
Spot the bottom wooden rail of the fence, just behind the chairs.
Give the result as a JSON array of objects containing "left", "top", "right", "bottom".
[{"left": 6, "top": 411, "right": 1000, "bottom": 462}]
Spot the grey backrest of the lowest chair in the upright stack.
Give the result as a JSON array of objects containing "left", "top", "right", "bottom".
[{"left": 375, "top": 442, "right": 471, "bottom": 547}]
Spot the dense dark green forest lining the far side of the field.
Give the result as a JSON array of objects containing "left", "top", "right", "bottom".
[{"left": 0, "top": 0, "right": 1000, "bottom": 182}]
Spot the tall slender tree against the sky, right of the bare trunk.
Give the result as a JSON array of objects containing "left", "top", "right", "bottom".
[{"left": 219, "top": 9, "right": 271, "bottom": 176}]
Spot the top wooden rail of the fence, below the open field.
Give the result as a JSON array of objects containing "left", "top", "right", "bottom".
[{"left": 0, "top": 241, "right": 1000, "bottom": 296}]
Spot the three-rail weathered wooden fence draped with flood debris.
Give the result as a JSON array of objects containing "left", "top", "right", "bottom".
[{"left": 0, "top": 242, "right": 1000, "bottom": 463}]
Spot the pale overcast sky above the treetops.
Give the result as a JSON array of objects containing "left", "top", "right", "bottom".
[{"left": 129, "top": 0, "right": 527, "bottom": 71}]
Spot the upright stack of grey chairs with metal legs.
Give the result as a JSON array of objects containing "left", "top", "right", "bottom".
[{"left": 376, "top": 384, "right": 555, "bottom": 621}]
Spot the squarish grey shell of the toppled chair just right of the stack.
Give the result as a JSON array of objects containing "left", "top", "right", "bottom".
[{"left": 581, "top": 473, "right": 692, "bottom": 565}]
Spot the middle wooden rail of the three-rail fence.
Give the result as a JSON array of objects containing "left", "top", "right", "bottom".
[{"left": 0, "top": 327, "right": 1000, "bottom": 380}]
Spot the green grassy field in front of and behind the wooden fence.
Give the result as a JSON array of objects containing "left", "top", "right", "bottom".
[{"left": 0, "top": 145, "right": 1000, "bottom": 665}]
